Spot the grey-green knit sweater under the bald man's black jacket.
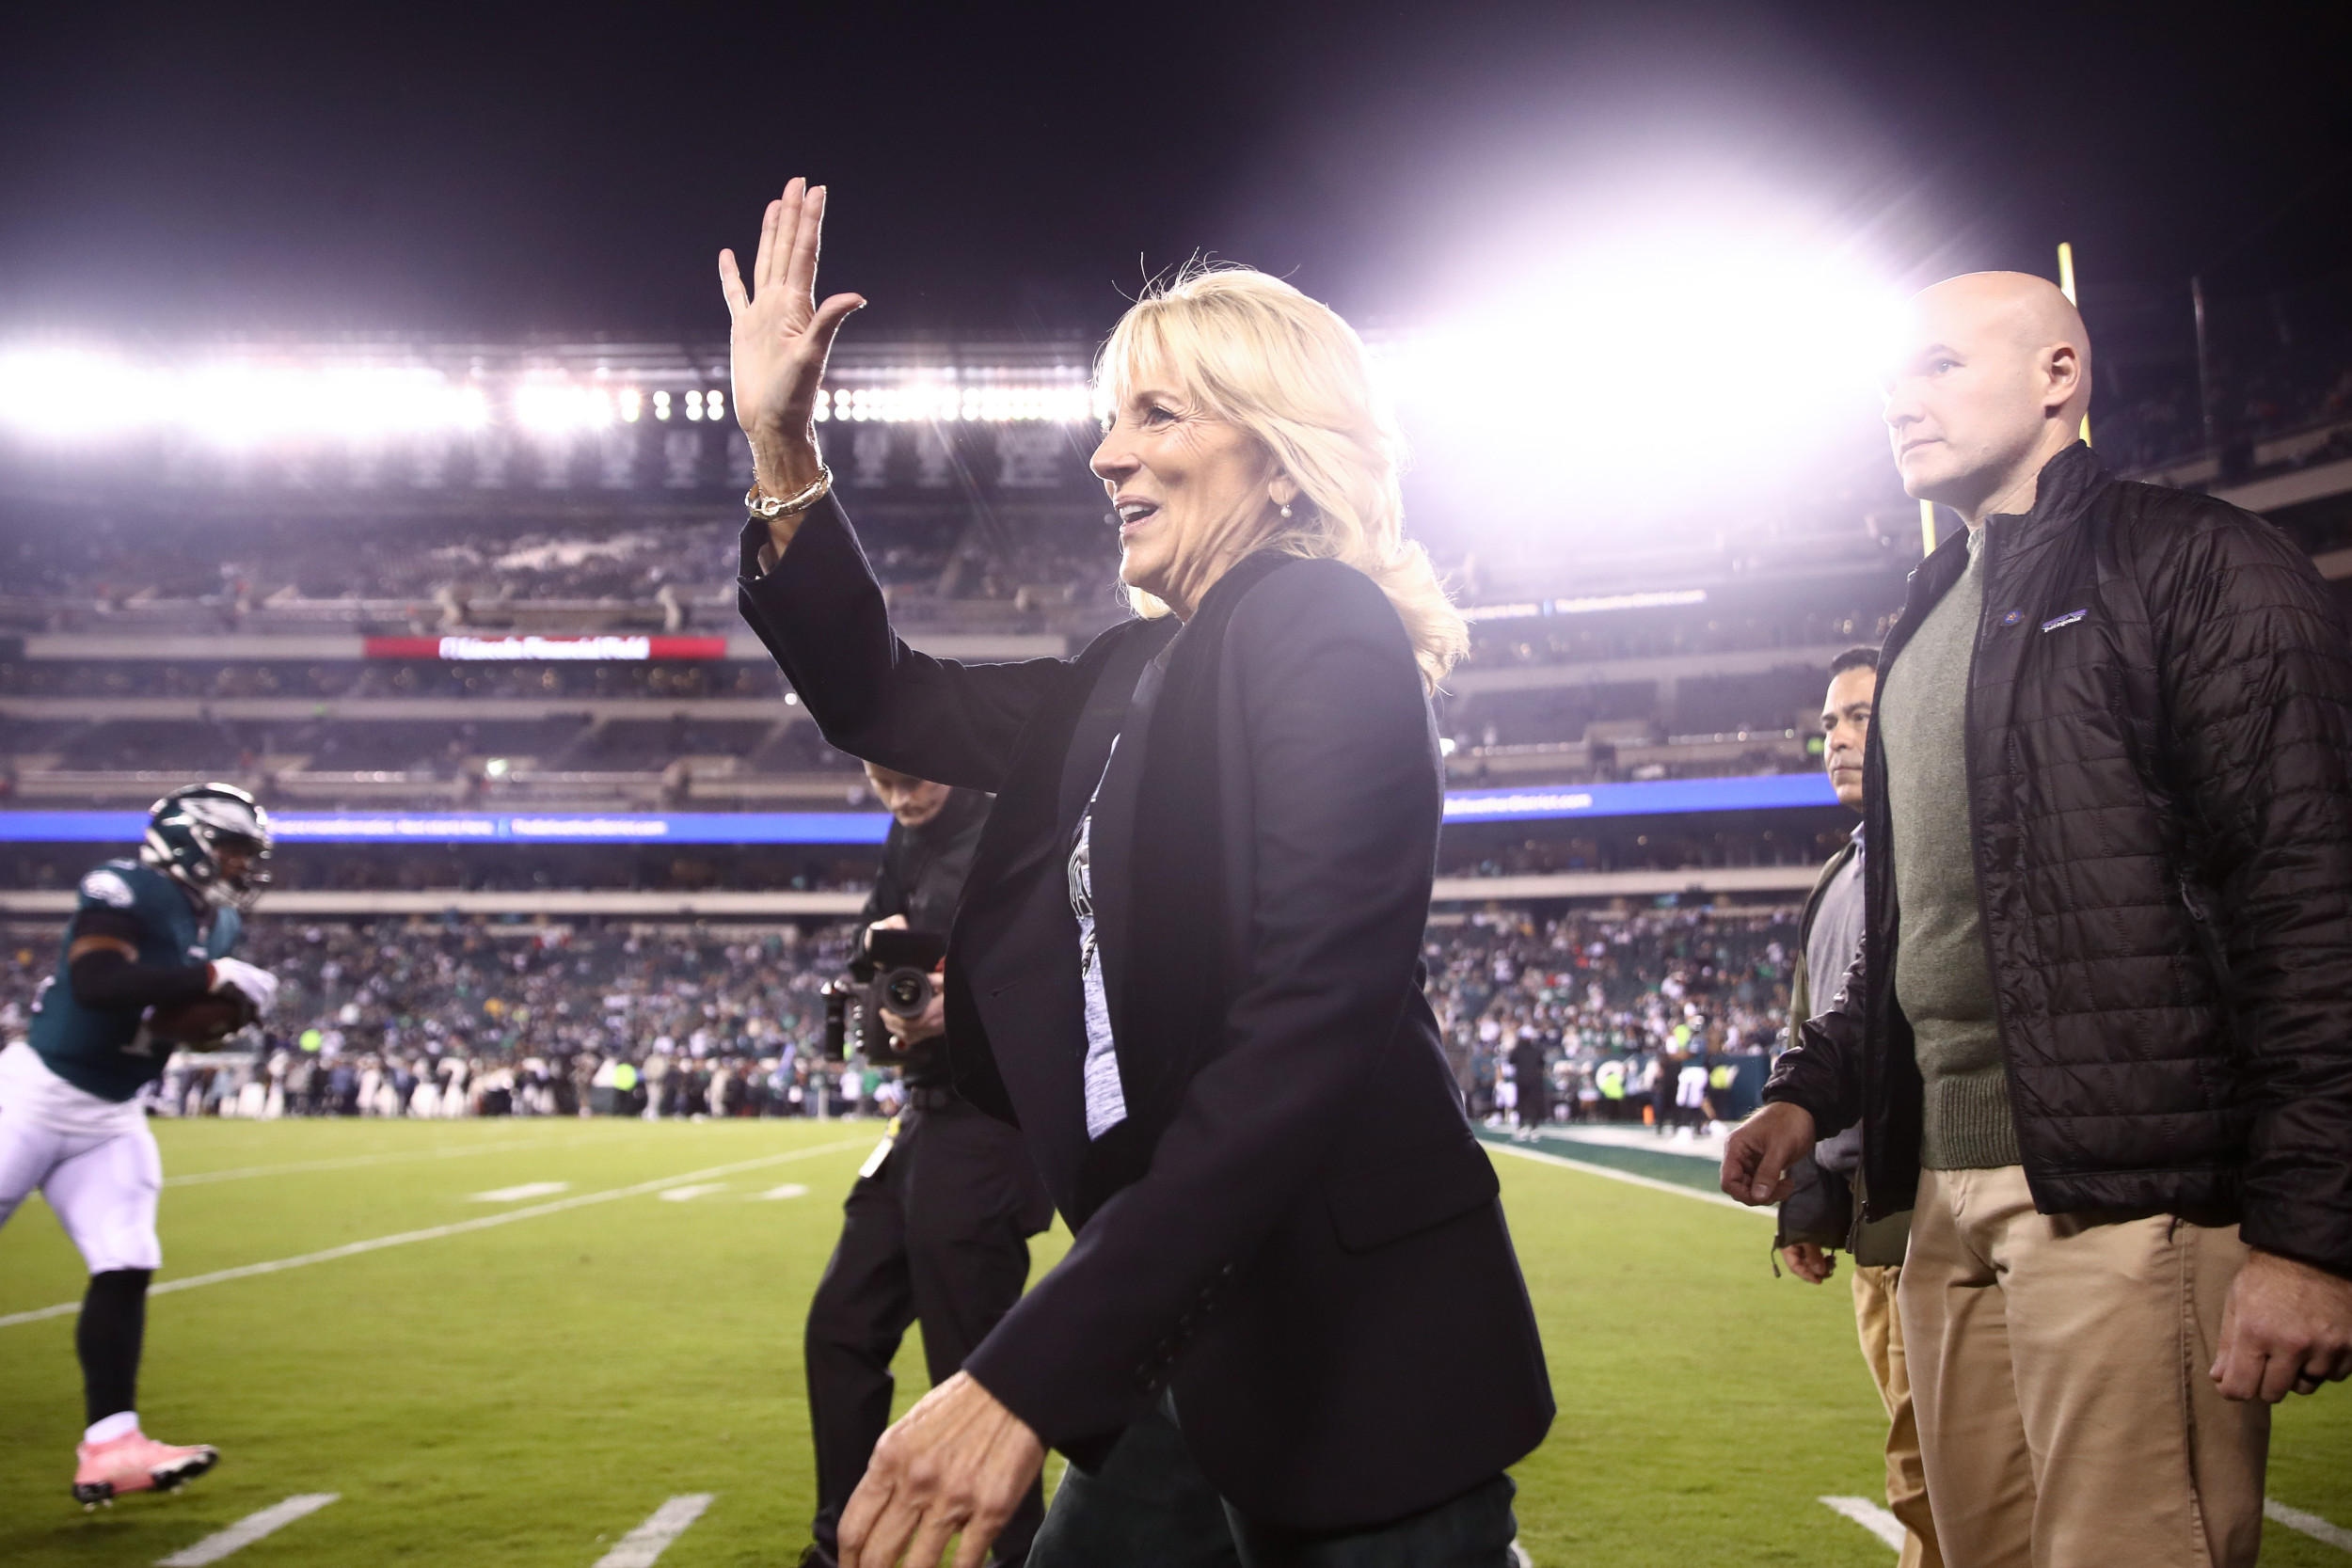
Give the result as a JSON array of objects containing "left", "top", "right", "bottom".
[{"left": 1872, "top": 529, "right": 2021, "bottom": 1171}]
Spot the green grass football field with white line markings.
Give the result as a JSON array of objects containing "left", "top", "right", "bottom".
[{"left": 0, "top": 1121, "right": 2352, "bottom": 1568}]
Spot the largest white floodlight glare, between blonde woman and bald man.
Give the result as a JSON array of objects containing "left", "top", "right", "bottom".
[{"left": 1376, "top": 195, "right": 1900, "bottom": 510}]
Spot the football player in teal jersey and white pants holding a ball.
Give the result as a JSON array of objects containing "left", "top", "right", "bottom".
[{"left": 0, "top": 783, "right": 278, "bottom": 1507}]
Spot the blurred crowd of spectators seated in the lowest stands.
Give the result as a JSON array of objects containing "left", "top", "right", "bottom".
[{"left": 0, "top": 908, "right": 1795, "bottom": 1129}]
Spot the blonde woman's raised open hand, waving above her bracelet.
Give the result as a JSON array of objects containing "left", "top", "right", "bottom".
[{"left": 720, "top": 179, "right": 866, "bottom": 496}]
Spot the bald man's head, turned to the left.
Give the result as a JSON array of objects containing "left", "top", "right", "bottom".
[{"left": 1884, "top": 273, "right": 2091, "bottom": 522}]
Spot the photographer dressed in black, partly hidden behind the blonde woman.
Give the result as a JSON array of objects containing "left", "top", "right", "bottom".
[{"left": 803, "top": 764, "right": 1052, "bottom": 1568}]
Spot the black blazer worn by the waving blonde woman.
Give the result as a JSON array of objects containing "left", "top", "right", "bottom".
[{"left": 739, "top": 500, "right": 1552, "bottom": 1528}]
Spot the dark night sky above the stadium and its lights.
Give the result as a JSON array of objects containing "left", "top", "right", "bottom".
[{"left": 0, "top": 0, "right": 2352, "bottom": 336}]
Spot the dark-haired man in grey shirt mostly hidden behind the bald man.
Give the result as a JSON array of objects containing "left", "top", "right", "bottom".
[{"left": 1781, "top": 649, "right": 1943, "bottom": 1568}]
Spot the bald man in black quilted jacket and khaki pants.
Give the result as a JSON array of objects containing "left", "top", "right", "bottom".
[{"left": 1724, "top": 273, "right": 2352, "bottom": 1568}]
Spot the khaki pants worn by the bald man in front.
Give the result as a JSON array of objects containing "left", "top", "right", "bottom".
[{"left": 1900, "top": 1166, "right": 2270, "bottom": 1568}]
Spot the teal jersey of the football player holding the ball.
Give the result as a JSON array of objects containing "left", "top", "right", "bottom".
[{"left": 28, "top": 861, "right": 245, "bottom": 1105}]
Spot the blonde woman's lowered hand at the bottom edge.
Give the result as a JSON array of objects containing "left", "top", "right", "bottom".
[{"left": 842, "top": 1373, "right": 1044, "bottom": 1568}]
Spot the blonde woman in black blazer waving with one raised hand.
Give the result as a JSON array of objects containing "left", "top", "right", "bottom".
[{"left": 720, "top": 181, "right": 1552, "bottom": 1568}]
